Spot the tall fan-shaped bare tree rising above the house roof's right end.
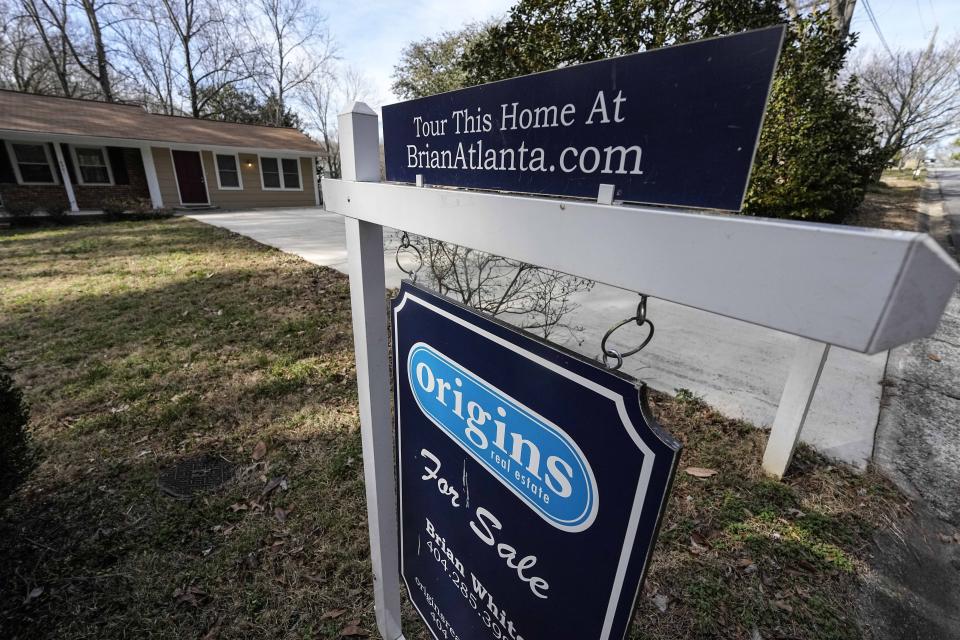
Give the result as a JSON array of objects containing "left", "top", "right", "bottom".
[{"left": 242, "top": 0, "right": 336, "bottom": 126}]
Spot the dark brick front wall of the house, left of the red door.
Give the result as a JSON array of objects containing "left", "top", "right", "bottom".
[{"left": 0, "top": 143, "right": 150, "bottom": 211}]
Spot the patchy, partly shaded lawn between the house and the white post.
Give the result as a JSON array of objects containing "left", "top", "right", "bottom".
[{"left": 0, "top": 221, "right": 382, "bottom": 638}]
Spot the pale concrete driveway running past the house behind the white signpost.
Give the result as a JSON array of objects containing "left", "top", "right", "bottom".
[{"left": 191, "top": 209, "right": 887, "bottom": 468}]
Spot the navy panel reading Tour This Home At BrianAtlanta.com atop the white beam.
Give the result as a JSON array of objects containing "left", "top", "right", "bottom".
[{"left": 383, "top": 26, "right": 784, "bottom": 211}]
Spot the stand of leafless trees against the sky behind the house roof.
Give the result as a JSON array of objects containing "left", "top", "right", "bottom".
[{"left": 0, "top": 0, "right": 350, "bottom": 131}]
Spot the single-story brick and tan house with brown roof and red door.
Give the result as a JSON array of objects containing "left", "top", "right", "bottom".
[{"left": 0, "top": 91, "right": 322, "bottom": 211}]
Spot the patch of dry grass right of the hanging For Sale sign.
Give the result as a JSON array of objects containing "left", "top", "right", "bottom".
[{"left": 631, "top": 391, "right": 904, "bottom": 640}]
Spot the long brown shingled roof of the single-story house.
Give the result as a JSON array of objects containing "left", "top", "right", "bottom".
[{"left": 0, "top": 91, "right": 321, "bottom": 153}]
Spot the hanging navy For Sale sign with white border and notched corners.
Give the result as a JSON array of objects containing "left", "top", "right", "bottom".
[{"left": 393, "top": 282, "right": 679, "bottom": 640}]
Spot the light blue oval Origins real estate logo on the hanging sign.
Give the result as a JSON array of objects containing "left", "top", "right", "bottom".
[{"left": 407, "top": 342, "right": 598, "bottom": 532}]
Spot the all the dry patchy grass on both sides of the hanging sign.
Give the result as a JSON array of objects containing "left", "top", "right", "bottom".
[{"left": 0, "top": 220, "right": 900, "bottom": 640}]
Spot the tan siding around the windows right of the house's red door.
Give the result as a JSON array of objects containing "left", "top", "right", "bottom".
[{"left": 202, "top": 151, "right": 317, "bottom": 209}]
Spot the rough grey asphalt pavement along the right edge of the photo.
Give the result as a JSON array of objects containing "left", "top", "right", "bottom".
[{"left": 861, "top": 171, "right": 960, "bottom": 640}]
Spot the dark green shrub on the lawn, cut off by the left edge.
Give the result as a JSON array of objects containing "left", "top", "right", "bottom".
[{"left": 0, "top": 365, "right": 36, "bottom": 500}]
